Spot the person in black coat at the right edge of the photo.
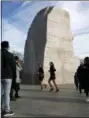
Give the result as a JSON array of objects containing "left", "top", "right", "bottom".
[{"left": 77, "top": 57, "right": 89, "bottom": 102}]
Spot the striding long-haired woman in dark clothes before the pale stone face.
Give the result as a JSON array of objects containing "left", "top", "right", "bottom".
[{"left": 48, "top": 62, "right": 59, "bottom": 92}]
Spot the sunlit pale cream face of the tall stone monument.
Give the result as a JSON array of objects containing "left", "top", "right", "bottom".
[{"left": 44, "top": 7, "right": 79, "bottom": 84}]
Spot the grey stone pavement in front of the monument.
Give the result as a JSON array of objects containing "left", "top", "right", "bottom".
[{"left": 11, "top": 85, "right": 89, "bottom": 118}]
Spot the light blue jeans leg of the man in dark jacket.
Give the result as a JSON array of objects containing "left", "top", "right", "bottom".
[{"left": 5, "top": 79, "right": 12, "bottom": 112}]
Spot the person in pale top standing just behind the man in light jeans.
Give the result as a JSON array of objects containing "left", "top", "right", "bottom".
[{"left": 15, "top": 56, "right": 22, "bottom": 98}]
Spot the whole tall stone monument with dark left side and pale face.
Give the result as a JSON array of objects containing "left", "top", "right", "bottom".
[{"left": 23, "top": 7, "right": 79, "bottom": 84}]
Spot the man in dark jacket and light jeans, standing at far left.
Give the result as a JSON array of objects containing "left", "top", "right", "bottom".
[{"left": 1, "top": 41, "right": 16, "bottom": 116}]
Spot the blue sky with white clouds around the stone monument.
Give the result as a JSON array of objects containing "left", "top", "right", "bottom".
[{"left": 2, "top": 1, "right": 89, "bottom": 58}]
